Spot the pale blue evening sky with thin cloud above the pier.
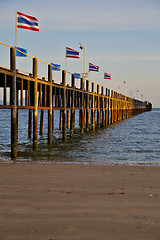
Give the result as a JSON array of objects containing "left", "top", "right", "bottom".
[{"left": 0, "top": 0, "right": 160, "bottom": 107}]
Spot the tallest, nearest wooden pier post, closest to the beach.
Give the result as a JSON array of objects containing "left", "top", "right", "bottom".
[{"left": 10, "top": 48, "right": 18, "bottom": 159}]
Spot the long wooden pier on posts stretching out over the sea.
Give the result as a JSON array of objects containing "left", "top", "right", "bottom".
[{"left": 0, "top": 47, "right": 152, "bottom": 159}]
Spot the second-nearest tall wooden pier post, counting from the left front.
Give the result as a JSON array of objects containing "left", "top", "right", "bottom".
[{"left": 33, "top": 58, "right": 38, "bottom": 151}]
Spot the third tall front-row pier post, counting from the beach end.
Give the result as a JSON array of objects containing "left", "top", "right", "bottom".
[{"left": 48, "top": 64, "right": 52, "bottom": 145}]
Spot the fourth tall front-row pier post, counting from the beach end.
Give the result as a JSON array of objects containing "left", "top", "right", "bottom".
[{"left": 62, "top": 70, "right": 67, "bottom": 141}]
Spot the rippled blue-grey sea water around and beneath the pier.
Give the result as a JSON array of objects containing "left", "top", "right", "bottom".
[{"left": 0, "top": 108, "right": 160, "bottom": 166}]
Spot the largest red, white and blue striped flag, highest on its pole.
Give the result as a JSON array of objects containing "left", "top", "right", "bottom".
[{"left": 17, "top": 12, "right": 39, "bottom": 31}]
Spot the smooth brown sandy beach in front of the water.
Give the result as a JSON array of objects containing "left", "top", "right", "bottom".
[{"left": 0, "top": 163, "right": 160, "bottom": 240}]
